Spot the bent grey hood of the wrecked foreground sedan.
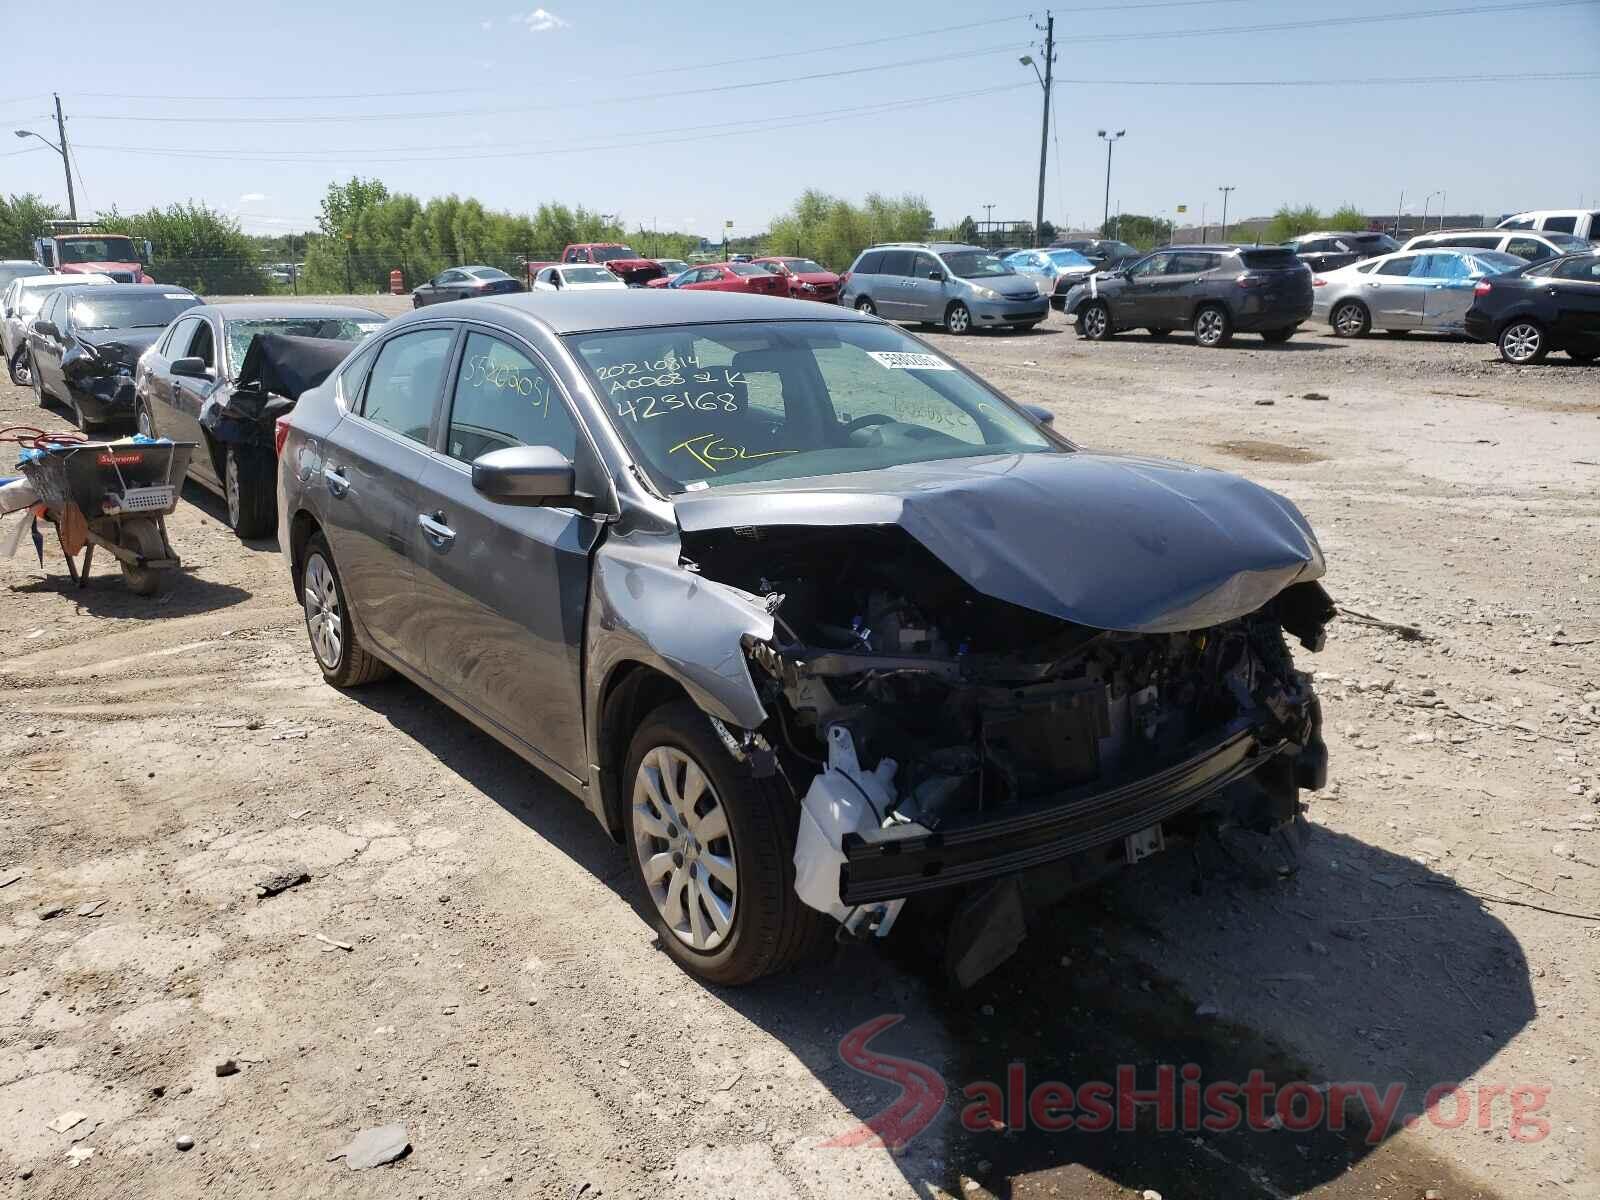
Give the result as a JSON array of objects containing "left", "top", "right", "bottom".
[{"left": 674, "top": 451, "right": 1325, "bottom": 634}]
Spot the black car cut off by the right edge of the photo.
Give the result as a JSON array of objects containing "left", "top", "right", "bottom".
[{"left": 1466, "top": 250, "right": 1600, "bottom": 366}]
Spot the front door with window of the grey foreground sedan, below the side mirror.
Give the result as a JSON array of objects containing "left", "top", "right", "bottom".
[{"left": 411, "top": 326, "right": 602, "bottom": 778}]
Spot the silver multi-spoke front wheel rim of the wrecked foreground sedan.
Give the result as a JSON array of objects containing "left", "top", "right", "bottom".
[{"left": 632, "top": 746, "right": 739, "bottom": 952}]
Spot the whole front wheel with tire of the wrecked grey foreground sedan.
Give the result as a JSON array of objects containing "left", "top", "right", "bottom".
[{"left": 622, "top": 701, "right": 830, "bottom": 986}]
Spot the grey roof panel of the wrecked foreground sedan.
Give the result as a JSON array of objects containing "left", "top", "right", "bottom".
[{"left": 395, "top": 288, "right": 874, "bottom": 334}]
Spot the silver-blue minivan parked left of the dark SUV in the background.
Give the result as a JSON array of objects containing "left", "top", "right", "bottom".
[{"left": 838, "top": 242, "right": 1050, "bottom": 333}]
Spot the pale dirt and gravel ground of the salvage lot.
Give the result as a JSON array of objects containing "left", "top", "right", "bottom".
[{"left": 0, "top": 301, "right": 1600, "bottom": 1200}]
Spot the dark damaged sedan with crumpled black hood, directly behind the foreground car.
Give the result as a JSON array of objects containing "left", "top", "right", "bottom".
[{"left": 131, "top": 302, "right": 386, "bottom": 538}]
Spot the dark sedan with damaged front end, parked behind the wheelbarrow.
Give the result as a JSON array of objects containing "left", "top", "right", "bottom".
[{"left": 27, "top": 283, "right": 205, "bottom": 434}]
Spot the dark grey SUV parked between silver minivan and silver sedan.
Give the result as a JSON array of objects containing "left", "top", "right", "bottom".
[{"left": 1066, "top": 246, "right": 1312, "bottom": 347}]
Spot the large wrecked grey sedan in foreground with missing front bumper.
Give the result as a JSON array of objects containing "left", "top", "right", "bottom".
[{"left": 278, "top": 288, "right": 1333, "bottom": 984}]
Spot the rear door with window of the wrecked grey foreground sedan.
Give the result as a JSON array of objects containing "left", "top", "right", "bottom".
[{"left": 320, "top": 322, "right": 458, "bottom": 670}]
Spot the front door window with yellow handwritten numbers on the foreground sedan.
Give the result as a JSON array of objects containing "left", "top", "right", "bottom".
[{"left": 445, "top": 333, "right": 578, "bottom": 462}]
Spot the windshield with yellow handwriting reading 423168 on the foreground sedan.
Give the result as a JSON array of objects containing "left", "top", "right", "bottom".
[{"left": 568, "top": 322, "right": 1059, "bottom": 493}]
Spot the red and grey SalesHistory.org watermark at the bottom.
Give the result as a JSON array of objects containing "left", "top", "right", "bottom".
[{"left": 826, "top": 1013, "right": 1550, "bottom": 1149}]
